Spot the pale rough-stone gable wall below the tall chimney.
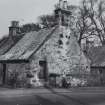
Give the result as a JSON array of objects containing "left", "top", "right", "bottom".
[{"left": 31, "top": 27, "right": 90, "bottom": 86}]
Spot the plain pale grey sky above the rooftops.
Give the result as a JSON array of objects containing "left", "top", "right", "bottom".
[{"left": 0, "top": 0, "right": 80, "bottom": 38}]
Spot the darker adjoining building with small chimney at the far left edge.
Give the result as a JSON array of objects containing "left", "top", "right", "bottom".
[{"left": 0, "top": 21, "right": 24, "bottom": 84}]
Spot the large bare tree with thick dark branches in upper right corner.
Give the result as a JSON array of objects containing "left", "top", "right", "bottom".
[{"left": 77, "top": 0, "right": 105, "bottom": 45}]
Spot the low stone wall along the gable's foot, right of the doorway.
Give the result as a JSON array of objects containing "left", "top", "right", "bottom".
[{"left": 49, "top": 74, "right": 105, "bottom": 87}]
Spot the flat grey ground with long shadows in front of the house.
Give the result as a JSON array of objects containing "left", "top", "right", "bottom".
[{"left": 0, "top": 87, "right": 105, "bottom": 105}]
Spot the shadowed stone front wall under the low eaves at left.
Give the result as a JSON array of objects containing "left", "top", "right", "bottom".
[{"left": 6, "top": 63, "right": 30, "bottom": 87}]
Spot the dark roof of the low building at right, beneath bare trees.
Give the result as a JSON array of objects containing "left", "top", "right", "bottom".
[{"left": 88, "top": 46, "right": 105, "bottom": 67}]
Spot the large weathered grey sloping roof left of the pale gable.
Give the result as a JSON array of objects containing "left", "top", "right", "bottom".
[{"left": 0, "top": 27, "right": 56, "bottom": 62}]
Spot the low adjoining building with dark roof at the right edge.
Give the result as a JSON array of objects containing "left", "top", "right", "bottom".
[{"left": 87, "top": 45, "right": 105, "bottom": 85}]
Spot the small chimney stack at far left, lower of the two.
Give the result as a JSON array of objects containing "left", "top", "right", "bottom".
[{"left": 9, "top": 21, "right": 19, "bottom": 36}]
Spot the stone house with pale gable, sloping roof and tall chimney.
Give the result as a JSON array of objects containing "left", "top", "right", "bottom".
[{"left": 0, "top": 1, "right": 90, "bottom": 86}]
